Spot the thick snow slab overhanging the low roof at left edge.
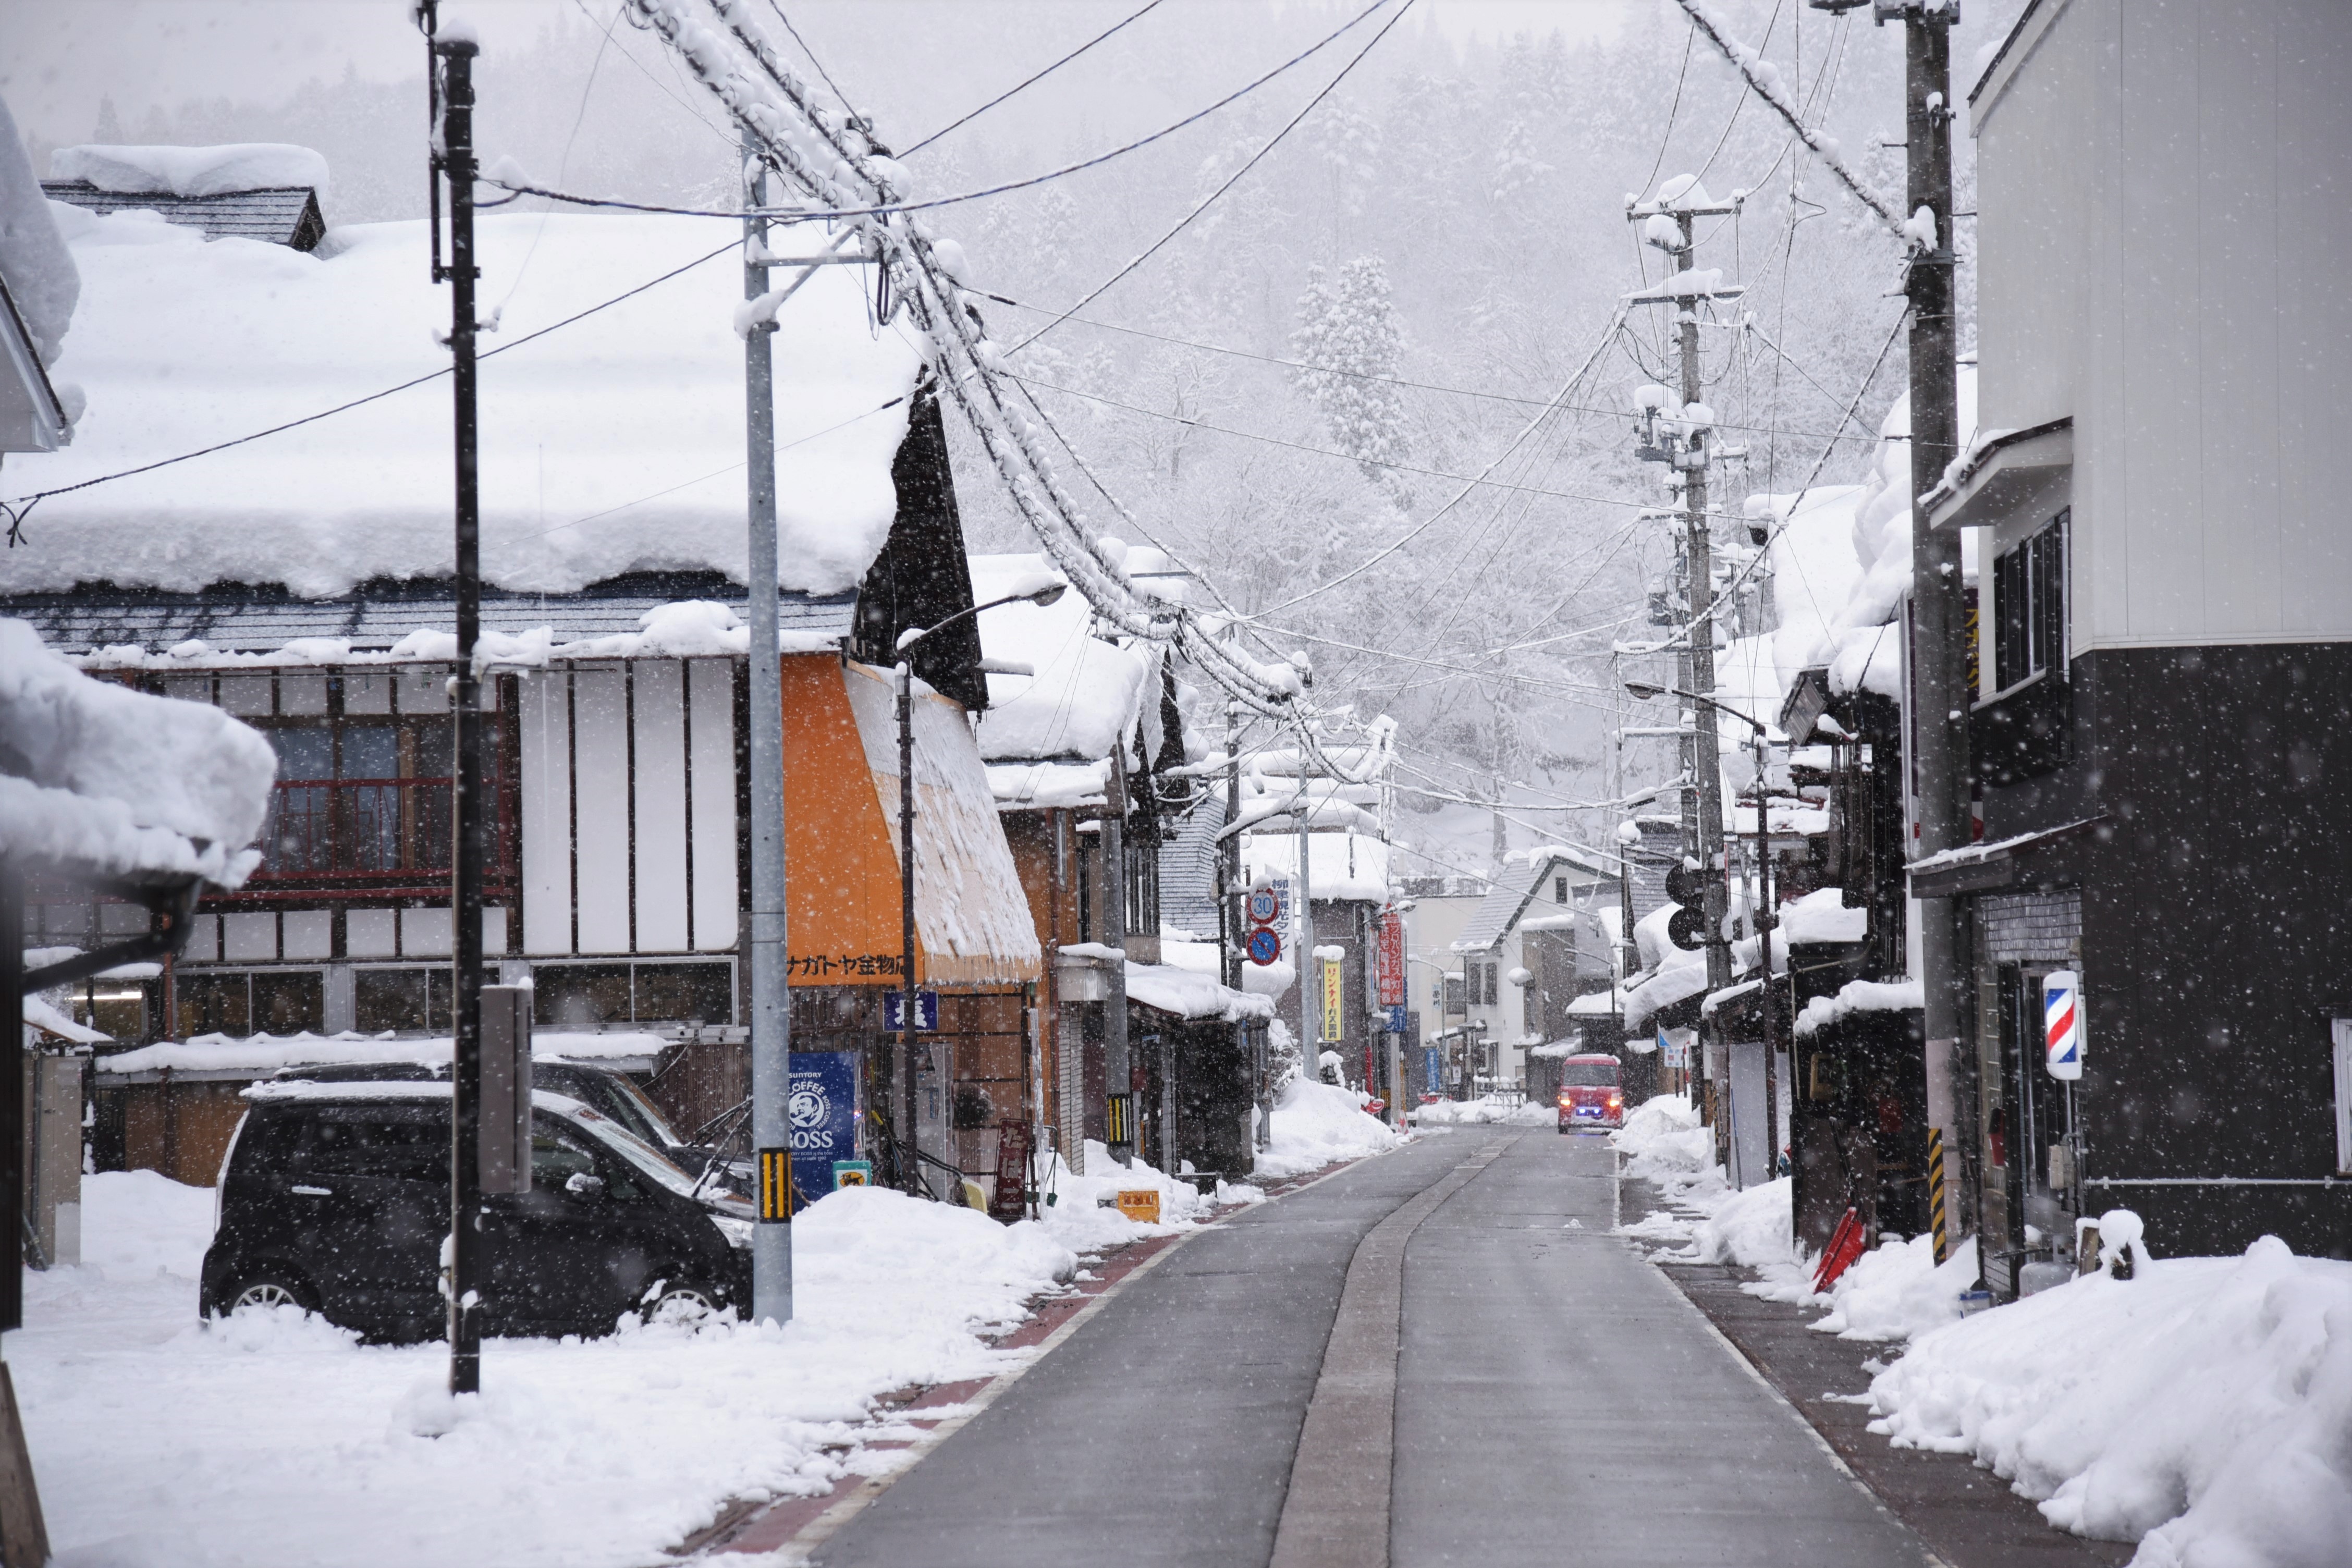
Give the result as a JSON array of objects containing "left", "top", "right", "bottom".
[{"left": 0, "top": 621, "right": 277, "bottom": 889}]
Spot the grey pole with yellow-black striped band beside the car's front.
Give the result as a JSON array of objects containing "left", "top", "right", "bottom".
[{"left": 743, "top": 134, "right": 793, "bottom": 1324}]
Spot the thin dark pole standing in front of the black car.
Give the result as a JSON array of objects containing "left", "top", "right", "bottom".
[{"left": 433, "top": 28, "right": 484, "bottom": 1394}]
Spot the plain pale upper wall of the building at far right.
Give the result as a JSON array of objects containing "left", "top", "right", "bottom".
[{"left": 1971, "top": 0, "right": 2352, "bottom": 651}]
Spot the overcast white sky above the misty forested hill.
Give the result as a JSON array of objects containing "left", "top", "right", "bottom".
[{"left": 0, "top": 0, "right": 1642, "bottom": 143}]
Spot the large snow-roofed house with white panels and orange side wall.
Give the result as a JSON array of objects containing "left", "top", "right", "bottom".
[{"left": 0, "top": 160, "right": 1042, "bottom": 1194}]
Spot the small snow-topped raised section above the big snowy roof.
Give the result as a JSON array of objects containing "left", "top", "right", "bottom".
[{"left": 40, "top": 141, "right": 327, "bottom": 252}]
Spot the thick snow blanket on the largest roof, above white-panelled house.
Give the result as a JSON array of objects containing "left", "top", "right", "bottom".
[{"left": 0, "top": 202, "right": 920, "bottom": 597}]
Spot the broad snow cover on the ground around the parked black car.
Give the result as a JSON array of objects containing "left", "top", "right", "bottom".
[{"left": 7, "top": 1171, "right": 1077, "bottom": 1568}]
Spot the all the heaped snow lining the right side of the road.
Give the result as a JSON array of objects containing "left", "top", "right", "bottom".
[{"left": 1616, "top": 1098, "right": 2352, "bottom": 1568}]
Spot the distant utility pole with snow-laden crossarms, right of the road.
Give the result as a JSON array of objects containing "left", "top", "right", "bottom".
[{"left": 1625, "top": 179, "right": 1741, "bottom": 1143}]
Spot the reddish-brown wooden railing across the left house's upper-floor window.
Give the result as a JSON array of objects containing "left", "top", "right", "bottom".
[{"left": 254, "top": 778, "right": 513, "bottom": 884}]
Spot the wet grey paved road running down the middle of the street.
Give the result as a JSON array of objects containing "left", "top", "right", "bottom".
[{"left": 816, "top": 1129, "right": 1921, "bottom": 1568}]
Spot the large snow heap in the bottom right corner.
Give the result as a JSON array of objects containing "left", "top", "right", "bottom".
[{"left": 1870, "top": 1236, "right": 2352, "bottom": 1568}]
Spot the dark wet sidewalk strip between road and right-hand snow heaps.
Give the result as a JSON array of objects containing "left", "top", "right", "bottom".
[{"left": 1623, "top": 1180, "right": 2138, "bottom": 1568}]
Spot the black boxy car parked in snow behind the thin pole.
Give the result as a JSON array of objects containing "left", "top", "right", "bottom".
[{"left": 200, "top": 1081, "right": 753, "bottom": 1340}]
